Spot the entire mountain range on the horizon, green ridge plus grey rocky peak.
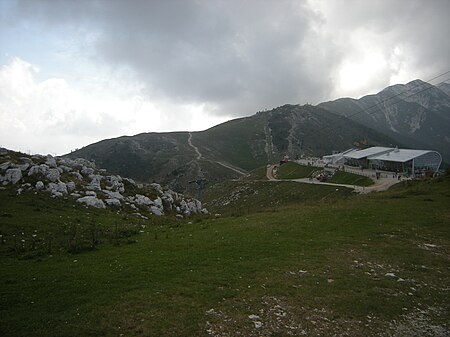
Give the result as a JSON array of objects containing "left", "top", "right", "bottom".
[{"left": 66, "top": 80, "right": 450, "bottom": 191}]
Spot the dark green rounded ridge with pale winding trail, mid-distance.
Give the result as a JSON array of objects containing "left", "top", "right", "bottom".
[{"left": 67, "top": 105, "right": 393, "bottom": 193}]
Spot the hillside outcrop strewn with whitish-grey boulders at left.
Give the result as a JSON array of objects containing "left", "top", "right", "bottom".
[{"left": 0, "top": 148, "right": 208, "bottom": 218}]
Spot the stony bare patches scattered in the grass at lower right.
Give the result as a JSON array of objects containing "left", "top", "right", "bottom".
[{"left": 204, "top": 244, "right": 450, "bottom": 337}]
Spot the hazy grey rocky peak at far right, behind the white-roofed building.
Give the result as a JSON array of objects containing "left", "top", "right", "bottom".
[{"left": 319, "top": 80, "right": 450, "bottom": 162}]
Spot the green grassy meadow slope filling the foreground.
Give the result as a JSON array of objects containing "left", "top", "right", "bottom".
[{"left": 0, "top": 179, "right": 450, "bottom": 336}]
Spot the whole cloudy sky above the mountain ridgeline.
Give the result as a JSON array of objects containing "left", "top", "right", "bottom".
[{"left": 0, "top": 0, "right": 450, "bottom": 155}]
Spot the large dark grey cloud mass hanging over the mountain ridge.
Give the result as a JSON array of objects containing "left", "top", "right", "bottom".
[{"left": 10, "top": 0, "right": 450, "bottom": 116}]
